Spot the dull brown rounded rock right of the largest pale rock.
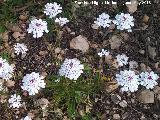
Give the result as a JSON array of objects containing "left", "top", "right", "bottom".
[{"left": 109, "top": 35, "right": 122, "bottom": 49}]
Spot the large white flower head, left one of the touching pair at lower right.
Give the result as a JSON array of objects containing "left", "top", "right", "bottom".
[{"left": 116, "top": 70, "right": 139, "bottom": 92}]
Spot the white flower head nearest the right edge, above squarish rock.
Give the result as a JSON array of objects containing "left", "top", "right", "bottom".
[{"left": 140, "top": 71, "right": 159, "bottom": 89}]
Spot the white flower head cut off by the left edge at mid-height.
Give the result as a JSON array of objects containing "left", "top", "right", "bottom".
[{"left": 0, "top": 58, "right": 14, "bottom": 80}]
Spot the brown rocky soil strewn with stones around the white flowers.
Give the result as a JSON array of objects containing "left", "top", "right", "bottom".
[{"left": 0, "top": 0, "right": 160, "bottom": 120}]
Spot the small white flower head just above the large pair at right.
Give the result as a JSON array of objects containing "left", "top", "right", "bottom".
[{"left": 116, "top": 54, "right": 129, "bottom": 66}]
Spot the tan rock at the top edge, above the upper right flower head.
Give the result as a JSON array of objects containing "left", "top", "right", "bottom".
[{"left": 126, "top": 0, "right": 138, "bottom": 13}]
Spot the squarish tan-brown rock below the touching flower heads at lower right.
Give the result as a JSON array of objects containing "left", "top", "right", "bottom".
[{"left": 137, "top": 90, "right": 154, "bottom": 104}]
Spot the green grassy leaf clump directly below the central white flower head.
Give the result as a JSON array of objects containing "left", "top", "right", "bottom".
[{"left": 46, "top": 66, "right": 100, "bottom": 118}]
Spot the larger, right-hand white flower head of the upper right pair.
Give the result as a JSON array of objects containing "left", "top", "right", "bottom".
[{"left": 112, "top": 13, "right": 134, "bottom": 32}]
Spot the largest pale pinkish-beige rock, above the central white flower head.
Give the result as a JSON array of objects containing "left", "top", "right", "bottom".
[{"left": 70, "top": 35, "right": 89, "bottom": 53}]
